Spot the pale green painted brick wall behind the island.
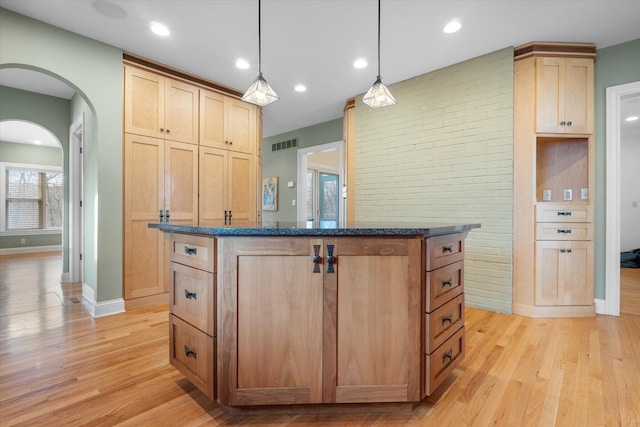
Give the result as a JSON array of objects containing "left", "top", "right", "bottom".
[{"left": 355, "top": 48, "right": 513, "bottom": 313}]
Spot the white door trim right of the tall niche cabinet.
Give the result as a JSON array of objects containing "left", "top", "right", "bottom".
[{"left": 603, "top": 81, "right": 640, "bottom": 316}]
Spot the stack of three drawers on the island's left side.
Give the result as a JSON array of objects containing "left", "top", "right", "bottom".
[{"left": 169, "top": 234, "right": 217, "bottom": 400}]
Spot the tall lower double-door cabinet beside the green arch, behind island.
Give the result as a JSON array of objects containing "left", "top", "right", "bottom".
[{"left": 123, "top": 134, "right": 198, "bottom": 299}]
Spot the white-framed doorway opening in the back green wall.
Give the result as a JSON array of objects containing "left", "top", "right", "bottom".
[{"left": 297, "top": 141, "right": 345, "bottom": 228}]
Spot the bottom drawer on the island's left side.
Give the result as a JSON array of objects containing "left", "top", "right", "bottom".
[{"left": 169, "top": 314, "right": 217, "bottom": 400}]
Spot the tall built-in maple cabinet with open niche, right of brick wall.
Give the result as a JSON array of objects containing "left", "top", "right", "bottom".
[{"left": 513, "top": 43, "right": 595, "bottom": 317}]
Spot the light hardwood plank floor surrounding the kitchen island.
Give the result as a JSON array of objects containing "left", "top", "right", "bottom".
[{"left": 0, "top": 255, "right": 640, "bottom": 427}]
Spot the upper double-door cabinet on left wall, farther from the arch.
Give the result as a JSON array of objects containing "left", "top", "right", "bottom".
[{"left": 200, "top": 90, "right": 257, "bottom": 154}]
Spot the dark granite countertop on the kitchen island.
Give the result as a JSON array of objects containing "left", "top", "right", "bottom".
[{"left": 149, "top": 222, "right": 480, "bottom": 237}]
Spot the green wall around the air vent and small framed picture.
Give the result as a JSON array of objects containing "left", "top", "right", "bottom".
[{"left": 262, "top": 117, "right": 342, "bottom": 222}]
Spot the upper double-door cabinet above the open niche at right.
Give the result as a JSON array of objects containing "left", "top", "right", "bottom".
[{"left": 536, "top": 56, "right": 594, "bottom": 134}]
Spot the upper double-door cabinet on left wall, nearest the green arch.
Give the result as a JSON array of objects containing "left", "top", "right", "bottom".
[{"left": 124, "top": 66, "right": 200, "bottom": 144}]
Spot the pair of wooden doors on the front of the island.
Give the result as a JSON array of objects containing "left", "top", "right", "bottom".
[{"left": 219, "top": 237, "right": 424, "bottom": 406}]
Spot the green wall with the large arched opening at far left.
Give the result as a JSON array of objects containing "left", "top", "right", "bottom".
[{"left": 0, "top": 9, "right": 123, "bottom": 302}]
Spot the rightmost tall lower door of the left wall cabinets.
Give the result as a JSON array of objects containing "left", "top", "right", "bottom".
[{"left": 227, "top": 151, "right": 257, "bottom": 224}]
